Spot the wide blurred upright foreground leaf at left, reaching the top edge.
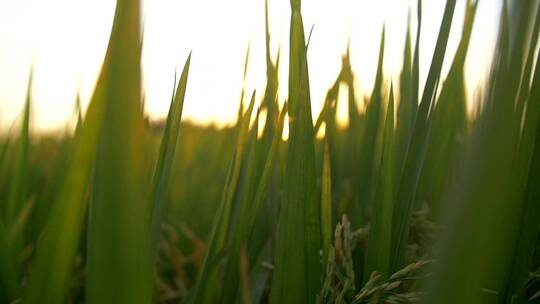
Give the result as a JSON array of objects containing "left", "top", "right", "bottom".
[{"left": 86, "top": 0, "right": 153, "bottom": 304}]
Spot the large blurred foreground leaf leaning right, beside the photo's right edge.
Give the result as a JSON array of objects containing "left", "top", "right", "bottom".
[{"left": 424, "top": 2, "right": 532, "bottom": 303}]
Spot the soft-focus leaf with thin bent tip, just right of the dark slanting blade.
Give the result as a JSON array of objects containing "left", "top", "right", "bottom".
[{"left": 416, "top": 1, "right": 477, "bottom": 221}]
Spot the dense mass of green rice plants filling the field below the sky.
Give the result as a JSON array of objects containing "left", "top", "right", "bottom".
[{"left": 0, "top": 0, "right": 540, "bottom": 304}]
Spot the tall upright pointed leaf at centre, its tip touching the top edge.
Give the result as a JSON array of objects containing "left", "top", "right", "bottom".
[{"left": 270, "top": 0, "right": 321, "bottom": 303}]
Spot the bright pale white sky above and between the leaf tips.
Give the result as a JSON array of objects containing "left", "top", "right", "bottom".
[{"left": 0, "top": 0, "right": 501, "bottom": 131}]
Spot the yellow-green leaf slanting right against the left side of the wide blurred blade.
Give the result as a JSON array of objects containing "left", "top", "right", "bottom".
[{"left": 23, "top": 58, "right": 111, "bottom": 303}]
